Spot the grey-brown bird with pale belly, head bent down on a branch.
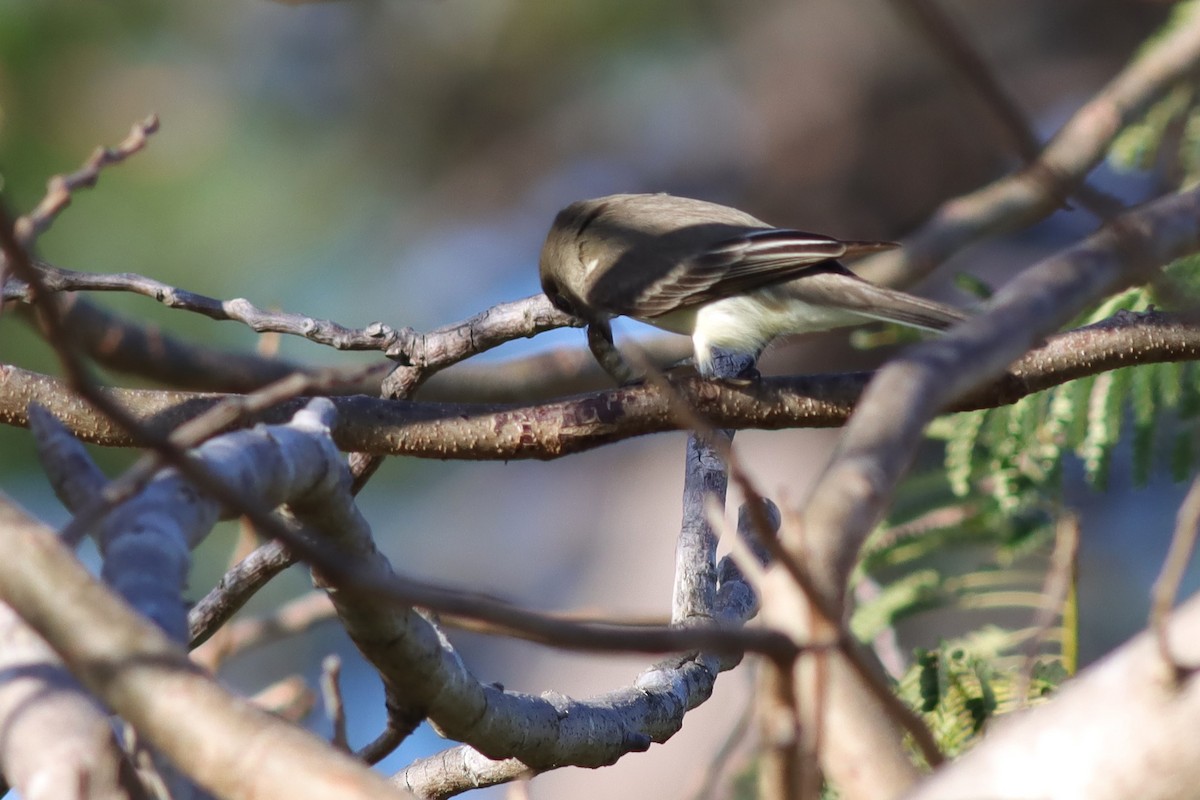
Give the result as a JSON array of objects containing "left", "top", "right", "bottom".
[{"left": 539, "top": 194, "right": 966, "bottom": 383}]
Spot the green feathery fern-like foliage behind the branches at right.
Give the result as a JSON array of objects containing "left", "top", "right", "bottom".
[{"left": 851, "top": 259, "right": 1200, "bottom": 756}]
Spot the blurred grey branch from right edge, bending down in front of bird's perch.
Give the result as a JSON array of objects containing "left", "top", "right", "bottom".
[{"left": 785, "top": 185, "right": 1200, "bottom": 607}]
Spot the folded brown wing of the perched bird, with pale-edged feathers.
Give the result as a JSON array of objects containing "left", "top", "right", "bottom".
[{"left": 622, "top": 229, "right": 896, "bottom": 318}]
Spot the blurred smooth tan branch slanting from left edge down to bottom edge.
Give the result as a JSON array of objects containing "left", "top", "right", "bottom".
[{"left": 0, "top": 498, "right": 410, "bottom": 800}]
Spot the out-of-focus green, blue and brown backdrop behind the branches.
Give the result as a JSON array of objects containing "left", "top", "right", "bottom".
[{"left": 0, "top": 0, "right": 1182, "bottom": 798}]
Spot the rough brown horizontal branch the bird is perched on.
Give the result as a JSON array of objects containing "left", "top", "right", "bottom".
[{"left": 7, "top": 313, "right": 1200, "bottom": 461}]
